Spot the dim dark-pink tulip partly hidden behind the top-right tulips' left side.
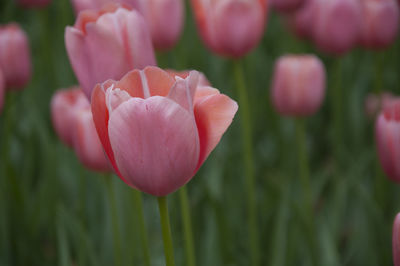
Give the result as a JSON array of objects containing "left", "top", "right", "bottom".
[{"left": 288, "top": 0, "right": 318, "bottom": 39}]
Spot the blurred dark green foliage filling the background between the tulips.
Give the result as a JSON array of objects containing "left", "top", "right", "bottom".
[{"left": 0, "top": 0, "right": 400, "bottom": 266}]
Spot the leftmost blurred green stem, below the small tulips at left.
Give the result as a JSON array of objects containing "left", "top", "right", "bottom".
[{"left": 105, "top": 175, "right": 121, "bottom": 266}]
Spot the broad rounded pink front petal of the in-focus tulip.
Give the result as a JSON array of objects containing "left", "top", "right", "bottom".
[{"left": 109, "top": 96, "right": 199, "bottom": 196}]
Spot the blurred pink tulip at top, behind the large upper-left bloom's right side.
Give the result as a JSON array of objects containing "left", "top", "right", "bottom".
[{"left": 143, "top": 0, "right": 184, "bottom": 50}]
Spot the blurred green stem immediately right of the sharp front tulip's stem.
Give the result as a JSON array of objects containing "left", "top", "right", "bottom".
[{"left": 179, "top": 186, "right": 196, "bottom": 266}]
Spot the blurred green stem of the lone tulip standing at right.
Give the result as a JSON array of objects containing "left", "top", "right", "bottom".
[{"left": 296, "top": 118, "right": 319, "bottom": 265}]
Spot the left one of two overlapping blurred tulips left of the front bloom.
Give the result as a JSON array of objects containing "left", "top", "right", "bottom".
[{"left": 50, "top": 87, "right": 90, "bottom": 147}]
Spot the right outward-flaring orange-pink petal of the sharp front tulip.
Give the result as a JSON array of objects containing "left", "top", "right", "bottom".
[{"left": 194, "top": 94, "right": 238, "bottom": 169}]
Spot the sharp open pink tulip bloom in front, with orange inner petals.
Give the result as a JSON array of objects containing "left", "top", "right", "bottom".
[{"left": 92, "top": 67, "right": 238, "bottom": 196}]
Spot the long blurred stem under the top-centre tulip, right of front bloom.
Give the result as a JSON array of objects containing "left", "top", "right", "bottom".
[{"left": 234, "top": 61, "right": 260, "bottom": 266}]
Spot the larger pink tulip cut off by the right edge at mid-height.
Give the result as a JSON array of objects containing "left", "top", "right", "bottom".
[{"left": 375, "top": 100, "right": 400, "bottom": 183}]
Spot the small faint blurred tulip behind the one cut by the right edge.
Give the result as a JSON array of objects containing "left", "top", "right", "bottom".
[{"left": 365, "top": 92, "right": 397, "bottom": 119}]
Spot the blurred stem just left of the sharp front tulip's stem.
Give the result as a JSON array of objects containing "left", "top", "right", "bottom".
[{"left": 132, "top": 189, "right": 151, "bottom": 266}]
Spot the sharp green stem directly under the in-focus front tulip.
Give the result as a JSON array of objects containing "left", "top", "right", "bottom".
[{"left": 157, "top": 197, "right": 175, "bottom": 266}]
